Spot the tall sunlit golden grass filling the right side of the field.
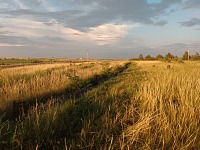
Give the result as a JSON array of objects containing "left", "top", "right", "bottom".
[{"left": 123, "top": 62, "right": 200, "bottom": 149}]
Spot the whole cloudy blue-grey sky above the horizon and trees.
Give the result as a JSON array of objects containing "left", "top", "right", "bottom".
[{"left": 0, "top": 0, "right": 200, "bottom": 59}]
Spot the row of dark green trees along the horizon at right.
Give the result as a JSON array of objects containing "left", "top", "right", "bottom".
[{"left": 134, "top": 52, "right": 200, "bottom": 61}]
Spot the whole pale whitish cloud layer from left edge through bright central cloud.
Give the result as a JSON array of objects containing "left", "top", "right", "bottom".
[{"left": 0, "top": 14, "right": 139, "bottom": 46}]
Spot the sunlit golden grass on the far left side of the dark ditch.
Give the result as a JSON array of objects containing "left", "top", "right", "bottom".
[{"left": 0, "top": 61, "right": 126, "bottom": 109}]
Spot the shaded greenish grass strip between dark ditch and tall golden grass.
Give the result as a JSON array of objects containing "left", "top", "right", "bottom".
[{"left": 0, "top": 61, "right": 139, "bottom": 149}]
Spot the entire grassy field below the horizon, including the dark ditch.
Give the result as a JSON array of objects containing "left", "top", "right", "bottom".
[{"left": 0, "top": 60, "right": 200, "bottom": 150}]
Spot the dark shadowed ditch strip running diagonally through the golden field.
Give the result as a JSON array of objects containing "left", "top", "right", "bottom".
[{"left": 0, "top": 63, "right": 131, "bottom": 121}]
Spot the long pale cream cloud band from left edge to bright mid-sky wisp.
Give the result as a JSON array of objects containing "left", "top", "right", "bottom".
[{"left": 0, "top": 17, "right": 139, "bottom": 45}]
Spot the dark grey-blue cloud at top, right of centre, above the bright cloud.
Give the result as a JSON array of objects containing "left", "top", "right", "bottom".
[{"left": 69, "top": 0, "right": 173, "bottom": 28}]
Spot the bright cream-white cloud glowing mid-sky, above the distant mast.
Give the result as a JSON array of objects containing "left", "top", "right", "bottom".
[{"left": 54, "top": 24, "right": 139, "bottom": 45}]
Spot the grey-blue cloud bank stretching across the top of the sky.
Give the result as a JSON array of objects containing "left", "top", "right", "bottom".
[{"left": 1, "top": 0, "right": 182, "bottom": 31}]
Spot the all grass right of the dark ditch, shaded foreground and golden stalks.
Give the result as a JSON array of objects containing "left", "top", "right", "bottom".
[{"left": 0, "top": 62, "right": 200, "bottom": 150}]
